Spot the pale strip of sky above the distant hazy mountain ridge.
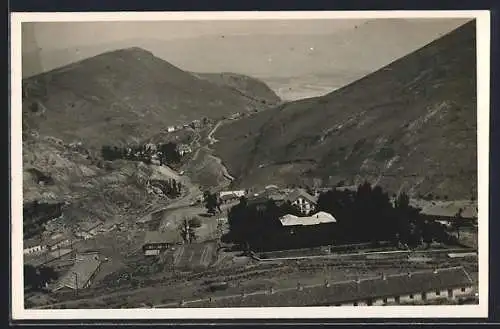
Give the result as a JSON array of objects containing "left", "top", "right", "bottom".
[{"left": 23, "top": 19, "right": 366, "bottom": 51}]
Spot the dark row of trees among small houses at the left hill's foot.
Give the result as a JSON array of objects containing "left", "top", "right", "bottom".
[{"left": 101, "top": 142, "right": 181, "bottom": 164}]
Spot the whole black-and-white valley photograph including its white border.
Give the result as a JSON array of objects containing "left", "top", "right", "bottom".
[{"left": 10, "top": 11, "right": 490, "bottom": 319}]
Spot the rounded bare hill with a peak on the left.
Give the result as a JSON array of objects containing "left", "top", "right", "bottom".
[{"left": 23, "top": 48, "right": 276, "bottom": 146}]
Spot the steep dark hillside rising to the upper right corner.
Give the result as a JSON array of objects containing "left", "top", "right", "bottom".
[{"left": 215, "top": 21, "right": 477, "bottom": 199}]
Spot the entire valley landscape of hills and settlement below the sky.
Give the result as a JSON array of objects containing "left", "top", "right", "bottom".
[{"left": 22, "top": 18, "right": 478, "bottom": 309}]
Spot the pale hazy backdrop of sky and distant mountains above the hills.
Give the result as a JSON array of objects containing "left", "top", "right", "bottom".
[{"left": 22, "top": 18, "right": 467, "bottom": 99}]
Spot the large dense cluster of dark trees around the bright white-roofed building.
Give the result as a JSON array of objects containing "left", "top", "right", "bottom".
[{"left": 224, "top": 183, "right": 460, "bottom": 250}]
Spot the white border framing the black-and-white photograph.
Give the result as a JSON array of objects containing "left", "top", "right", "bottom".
[{"left": 10, "top": 10, "right": 490, "bottom": 320}]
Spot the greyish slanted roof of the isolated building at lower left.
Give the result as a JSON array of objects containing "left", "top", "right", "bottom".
[{"left": 55, "top": 253, "right": 101, "bottom": 290}]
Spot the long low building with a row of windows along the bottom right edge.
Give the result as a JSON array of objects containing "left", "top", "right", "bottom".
[{"left": 167, "top": 267, "right": 477, "bottom": 307}]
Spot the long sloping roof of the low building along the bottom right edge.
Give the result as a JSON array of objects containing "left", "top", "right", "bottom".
[{"left": 180, "top": 267, "right": 473, "bottom": 307}]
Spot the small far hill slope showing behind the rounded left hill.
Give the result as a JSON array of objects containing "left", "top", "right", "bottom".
[{"left": 193, "top": 72, "right": 281, "bottom": 106}]
